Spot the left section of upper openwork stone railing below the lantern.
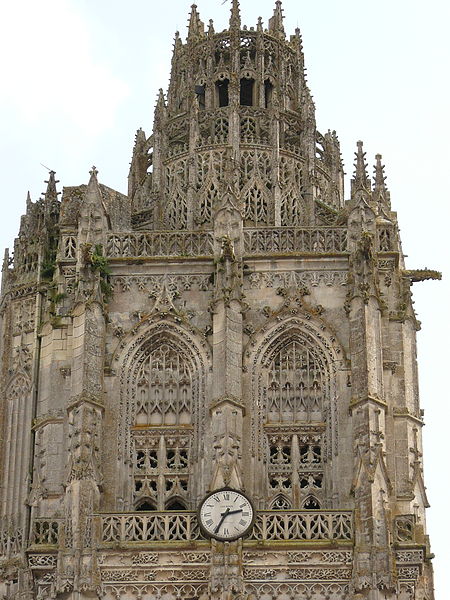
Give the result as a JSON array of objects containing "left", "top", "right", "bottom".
[{"left": 106, "top": 231, "right": 213, "bottom": 258}]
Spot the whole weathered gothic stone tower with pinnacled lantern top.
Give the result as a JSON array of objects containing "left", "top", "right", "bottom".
[{"left": 0, "top": 0, "right": 439, "bottom": 600}]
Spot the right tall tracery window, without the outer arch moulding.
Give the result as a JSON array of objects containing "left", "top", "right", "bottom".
[{"left": 262, "top": 333, "right": 330, "bottom": 510}]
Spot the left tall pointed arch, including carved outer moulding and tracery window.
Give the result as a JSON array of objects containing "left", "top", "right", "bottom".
[{"left": 116, "top": 314, "right": 209, "bottom": 510}]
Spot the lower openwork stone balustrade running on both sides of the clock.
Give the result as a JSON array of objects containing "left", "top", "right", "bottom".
[{"left": 98, "top": 511, "right": 353, "bottom": 543}]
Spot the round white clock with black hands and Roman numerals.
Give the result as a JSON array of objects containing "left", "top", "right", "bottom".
[{"left": 198, "top": 488, "right": 255, "bottom": 542}]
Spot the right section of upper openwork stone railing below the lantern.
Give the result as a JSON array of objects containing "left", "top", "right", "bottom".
[{"left": 244, "top": 227, "right": 347, "bottom": 254}]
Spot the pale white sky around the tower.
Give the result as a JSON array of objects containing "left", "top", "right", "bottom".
[{"left": 0, "top": 0, "right": 450, "bottom": 600}]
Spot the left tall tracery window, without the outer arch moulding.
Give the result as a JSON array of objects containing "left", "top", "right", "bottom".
[{"left": 119, "top": 333, "right": 203, "bottom": 511}]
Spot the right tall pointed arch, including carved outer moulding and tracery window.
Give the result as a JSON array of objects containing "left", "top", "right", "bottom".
[{"left": 244, "top": 311, "right": 341, "bottom": 508}]
